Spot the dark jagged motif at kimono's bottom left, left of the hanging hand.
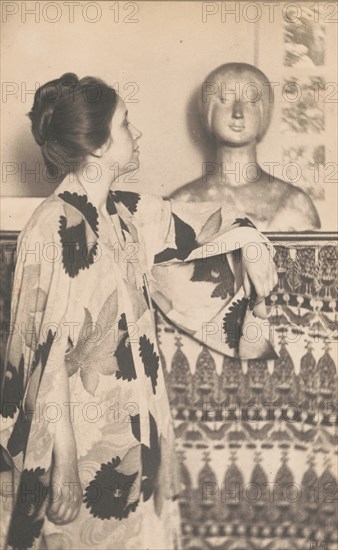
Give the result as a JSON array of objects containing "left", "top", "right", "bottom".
[{"left": 8, "top": 468, "right": 48, "bottom": 550}]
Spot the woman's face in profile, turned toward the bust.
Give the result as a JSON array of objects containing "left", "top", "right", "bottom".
[{"left": 103, "top": 97, "right": 142, "bottom": 177}]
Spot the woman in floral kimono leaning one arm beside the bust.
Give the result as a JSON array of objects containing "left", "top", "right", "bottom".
[{"left": 1, "top": 73, "right": 276, "bottom": 550}]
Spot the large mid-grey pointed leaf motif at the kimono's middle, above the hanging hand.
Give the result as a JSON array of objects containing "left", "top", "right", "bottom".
[{"left": 65, "top": 290, "right": 117, "bottom": 395}]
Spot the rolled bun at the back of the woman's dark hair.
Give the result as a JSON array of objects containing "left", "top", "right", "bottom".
[{"left": 28, "top": 73, "right": 79, "bottom": 147}]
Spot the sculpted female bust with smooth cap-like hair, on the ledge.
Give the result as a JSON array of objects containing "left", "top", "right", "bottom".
[{"left": 170, "top": 63, "right": 321, "bottom": 231}]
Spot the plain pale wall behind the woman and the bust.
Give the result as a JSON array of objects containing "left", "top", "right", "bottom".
[{"left": 2, "top": 1, "right": 338, "bottom": 230}]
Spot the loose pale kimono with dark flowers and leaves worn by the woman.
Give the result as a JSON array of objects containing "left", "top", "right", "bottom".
[{"left": 1, "top": 177, "right": 275, "bottom": 550}]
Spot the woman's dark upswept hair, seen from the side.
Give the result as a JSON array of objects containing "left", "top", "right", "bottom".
[{"left": 28, "top": 73, "right": 118, "bottom": 181}]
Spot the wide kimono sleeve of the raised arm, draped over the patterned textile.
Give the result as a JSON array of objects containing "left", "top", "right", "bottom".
[{"left": 132, "top": 199, "right": 277, "bottom": 359}]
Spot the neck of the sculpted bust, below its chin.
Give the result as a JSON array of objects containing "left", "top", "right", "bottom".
[{"left": 216, "top": 143, "right": 257, "bottom": 187}]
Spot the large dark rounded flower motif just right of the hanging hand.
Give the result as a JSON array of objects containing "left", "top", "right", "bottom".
[{"left": 83, "top": 456, "right": 139, "bottom": 520}]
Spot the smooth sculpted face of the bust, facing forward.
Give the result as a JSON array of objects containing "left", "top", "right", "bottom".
[{"left": 206, "top": 71, "right": 265, "bottom": 147}]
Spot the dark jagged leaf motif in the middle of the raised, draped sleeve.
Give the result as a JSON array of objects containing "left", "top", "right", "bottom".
[{"left": 190, "top": 254, "right": 235, "bottom": 300}]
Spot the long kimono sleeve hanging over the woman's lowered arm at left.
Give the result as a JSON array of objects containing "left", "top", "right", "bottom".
[{"left": 0, "top": 203, "right": 70, "bottom": 471}]
